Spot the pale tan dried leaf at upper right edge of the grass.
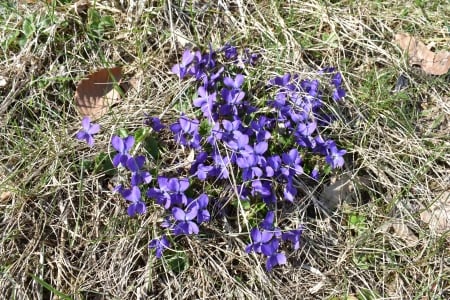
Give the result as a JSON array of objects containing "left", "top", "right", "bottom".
[{"left": 395, "top": 33, "right": 450, "bottom": 75}]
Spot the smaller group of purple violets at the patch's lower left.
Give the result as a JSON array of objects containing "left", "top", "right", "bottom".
[{"left": 111, "top": 135, "right": 210, "bottom": 257}]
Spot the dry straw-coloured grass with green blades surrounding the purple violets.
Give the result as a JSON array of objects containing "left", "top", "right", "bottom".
[{"left": 0, "top": 0, "right": 450, "bottom": 299}]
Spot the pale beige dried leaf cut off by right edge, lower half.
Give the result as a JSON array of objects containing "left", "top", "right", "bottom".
[{"left": 420, "top": 191, "right": 450, "bottom": 233}]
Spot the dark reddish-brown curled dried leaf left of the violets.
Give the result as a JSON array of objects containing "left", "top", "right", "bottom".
[{"left": 75, "top": 67, "right": 122, "bottom": 120}]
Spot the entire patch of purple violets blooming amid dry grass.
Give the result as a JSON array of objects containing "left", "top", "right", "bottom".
[{"left": 75, "top": 44, "right": 346, "bottom": 271}]
